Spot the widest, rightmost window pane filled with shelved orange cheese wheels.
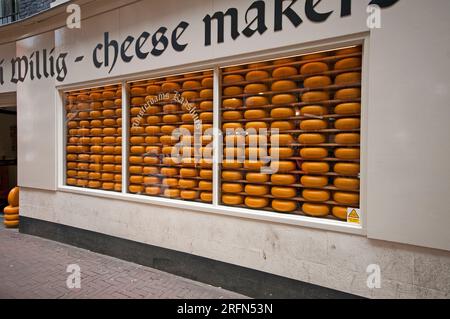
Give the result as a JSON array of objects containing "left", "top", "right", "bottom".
[{"left": 221, "top": 46, "right": 362, "bottom": 221}]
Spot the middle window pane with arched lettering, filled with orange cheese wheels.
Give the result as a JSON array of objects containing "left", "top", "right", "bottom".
[{"left": 129, "top": 71, "right": 213, "bottom": 203}]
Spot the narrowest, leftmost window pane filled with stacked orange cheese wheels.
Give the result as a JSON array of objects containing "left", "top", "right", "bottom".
[{"left": 66, "top": 85, "right": 122, "bottom": 192}]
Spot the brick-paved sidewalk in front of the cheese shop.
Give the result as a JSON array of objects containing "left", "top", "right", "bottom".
[{"left": 0, "top": 217, "right": 245, "bottom": 299}]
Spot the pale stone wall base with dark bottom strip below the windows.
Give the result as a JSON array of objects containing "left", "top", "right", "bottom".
[{"left": 20, "top": 188, "right": 450, "bottom": 298}]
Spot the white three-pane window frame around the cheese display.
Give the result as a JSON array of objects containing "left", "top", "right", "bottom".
[{"left": 55, "top": 33, "right": 370, "bottom": 236}]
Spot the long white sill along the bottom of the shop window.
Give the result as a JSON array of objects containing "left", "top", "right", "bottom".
[{"left": 58, "top": 186, "right": 365, "bottom": 236}]
